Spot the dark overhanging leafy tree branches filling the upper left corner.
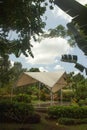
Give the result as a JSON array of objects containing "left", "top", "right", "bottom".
[{"left": 0, "top": 0, "right": 52, "bottom": 57}]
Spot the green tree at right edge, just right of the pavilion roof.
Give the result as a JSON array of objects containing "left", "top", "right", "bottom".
[{"left": 67, "top": 73, "right": 87, "bottom": 101}]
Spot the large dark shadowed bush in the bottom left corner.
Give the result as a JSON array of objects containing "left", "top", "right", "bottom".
[{"left": 0, "top": 101, "right": 40, "bottom": 123}]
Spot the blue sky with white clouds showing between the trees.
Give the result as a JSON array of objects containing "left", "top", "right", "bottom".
[{"left": 10, "top": 0, "right": 87, "bottom": 74}]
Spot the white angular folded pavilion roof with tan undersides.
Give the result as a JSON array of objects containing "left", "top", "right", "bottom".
[{"left": 16, "top": 71, "right": 67, "bottom": 93}]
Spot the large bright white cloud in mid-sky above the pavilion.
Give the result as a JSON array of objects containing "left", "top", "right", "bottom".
[{"left": 25, "top": 37, "right": 72, "bottom": 64}]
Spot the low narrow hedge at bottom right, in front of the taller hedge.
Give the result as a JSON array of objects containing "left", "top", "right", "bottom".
[{"left": 58, "top": 118, "right": 87, "bottom": 125}]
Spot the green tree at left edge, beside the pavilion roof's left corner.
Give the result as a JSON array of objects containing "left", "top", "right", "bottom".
[{"left": 0, "top": 55, "right": 26, "bottom": 87}]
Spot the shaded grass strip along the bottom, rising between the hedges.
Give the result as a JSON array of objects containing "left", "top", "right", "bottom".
[{"left": 0, "top": 113, "right": 87, "bottom": 130}]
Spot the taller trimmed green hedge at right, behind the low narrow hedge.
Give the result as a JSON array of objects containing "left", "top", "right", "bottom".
[{"left": 48, "top": 106, "right": 87, "bottom": 119}]
